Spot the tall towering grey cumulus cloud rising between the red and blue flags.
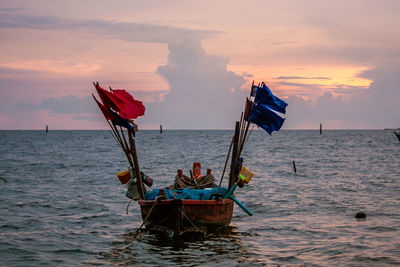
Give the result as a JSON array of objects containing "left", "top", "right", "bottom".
[{"left": 144, "top": 40, "right": 248, "bottom": 129}]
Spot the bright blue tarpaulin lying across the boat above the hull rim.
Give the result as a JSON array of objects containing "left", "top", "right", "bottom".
[{"left": 144, "top": 187, "right": 228, "bottom": 200}]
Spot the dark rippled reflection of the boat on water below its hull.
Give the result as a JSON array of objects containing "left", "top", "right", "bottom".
[{"left": 98, "top": 226, "right": 253, "bottom": 265}]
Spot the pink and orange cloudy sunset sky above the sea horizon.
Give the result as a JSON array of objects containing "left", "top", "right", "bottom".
[{"left": 0, "top": 0, "right": 400, "bottom": 130}]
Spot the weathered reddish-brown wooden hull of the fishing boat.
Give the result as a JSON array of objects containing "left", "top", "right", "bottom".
[{"left": 138, "top": 199, "right": 233, "bottom": 231}]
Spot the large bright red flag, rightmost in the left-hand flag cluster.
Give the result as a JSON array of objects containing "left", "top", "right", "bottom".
[{"left": 111, "top": 89, "right": 145, "bottom": 119}]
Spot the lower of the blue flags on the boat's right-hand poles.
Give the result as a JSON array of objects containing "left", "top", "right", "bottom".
[{"left": 249, "top": 103, "right": 285, "bottom": 135}]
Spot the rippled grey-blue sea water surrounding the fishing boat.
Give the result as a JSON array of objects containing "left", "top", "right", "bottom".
[{"left": 0, "top": 130, "right": 400, "bottom": 266}]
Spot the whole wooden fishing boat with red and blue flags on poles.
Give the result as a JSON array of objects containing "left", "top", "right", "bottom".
[{"left": 93, "top": 82, "right": 287, "bottom": 237}]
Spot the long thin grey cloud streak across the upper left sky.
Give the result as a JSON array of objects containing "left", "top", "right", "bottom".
[{"left": 0, "top": 13, "right": 221, "bottom": 43}]
